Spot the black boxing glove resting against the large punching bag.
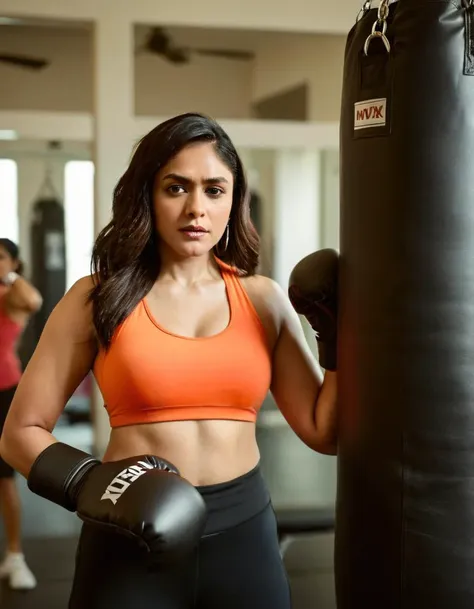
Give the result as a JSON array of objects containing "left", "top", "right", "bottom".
[{"left": 288, "top": 249, "right": 339, "bottom": 370}]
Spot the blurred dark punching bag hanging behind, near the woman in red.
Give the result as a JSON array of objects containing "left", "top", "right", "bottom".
[{"left": 31, "top": 197, "right": 66, "bottom": 342}]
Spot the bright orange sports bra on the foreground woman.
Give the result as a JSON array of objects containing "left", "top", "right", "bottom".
[{"left": 94, "top": 261, "right": 272, "bottom": 428}]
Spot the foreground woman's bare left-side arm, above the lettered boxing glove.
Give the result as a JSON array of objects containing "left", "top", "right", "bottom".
[{"left": 0, "top": 277, "right": 96, "bottom": 477}]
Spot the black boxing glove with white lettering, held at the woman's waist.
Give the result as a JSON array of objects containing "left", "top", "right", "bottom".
[{"left": 28, "top": 442, "right": 207, "bottom": 562}]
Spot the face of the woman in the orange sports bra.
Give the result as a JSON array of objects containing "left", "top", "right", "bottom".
[{"left": 154, "top": 142, "right": 234, "bottom": 257}]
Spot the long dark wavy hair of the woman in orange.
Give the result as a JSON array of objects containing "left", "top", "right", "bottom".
[{"left": 89, "top": 113, "right": 259, "bottom": 349}]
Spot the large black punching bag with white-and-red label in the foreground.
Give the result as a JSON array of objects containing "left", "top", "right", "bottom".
[{"left": 335, "top": 0, "right": 474, "bottom": 609}]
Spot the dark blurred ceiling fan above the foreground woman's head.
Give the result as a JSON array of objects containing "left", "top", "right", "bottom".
[{"left": 142, "top": 27, "right": 255, "bottom": 64}]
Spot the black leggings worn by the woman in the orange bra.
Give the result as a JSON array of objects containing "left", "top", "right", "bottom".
[{"left": 69, "top": 468, "right": 291, "bottom": 609}]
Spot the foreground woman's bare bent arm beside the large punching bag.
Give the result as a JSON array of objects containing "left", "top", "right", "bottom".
[{"left": 271, "top": 282, "right": 337, "bottom": 455}]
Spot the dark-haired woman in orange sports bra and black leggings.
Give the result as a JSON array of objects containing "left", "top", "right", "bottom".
[{"left": 1, "top": 114, "right": 336, "bottom": 609}]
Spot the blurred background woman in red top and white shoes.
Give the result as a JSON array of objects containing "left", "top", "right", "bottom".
[{"left": 0, "top": 239, "right": 41, "bottom": 590}]
